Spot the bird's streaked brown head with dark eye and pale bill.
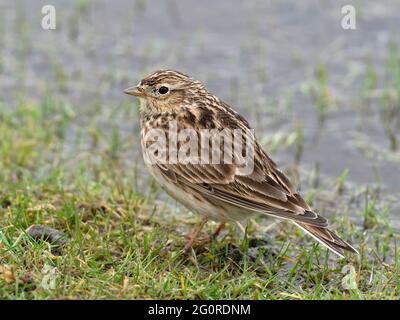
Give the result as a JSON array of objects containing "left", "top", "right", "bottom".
[{"left": 124, "top": 70, "right": 207, "bottom": 112}]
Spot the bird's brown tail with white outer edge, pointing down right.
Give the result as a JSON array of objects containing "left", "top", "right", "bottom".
[{"left": 295, "top": 222, "right": 358, "bottom": 258}]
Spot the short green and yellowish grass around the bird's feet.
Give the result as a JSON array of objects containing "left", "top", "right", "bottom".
[{"left": 0, "top": 97, "right": 400, "bottom": 299}]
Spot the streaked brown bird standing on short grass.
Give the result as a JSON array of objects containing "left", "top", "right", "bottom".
[{"left": 123, "top": 69, "right": 358, "bottom": 258}]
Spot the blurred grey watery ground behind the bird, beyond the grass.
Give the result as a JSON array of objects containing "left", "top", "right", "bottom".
[{"left": 0, "top": 0, "right": 400, "bottom": 222}]
